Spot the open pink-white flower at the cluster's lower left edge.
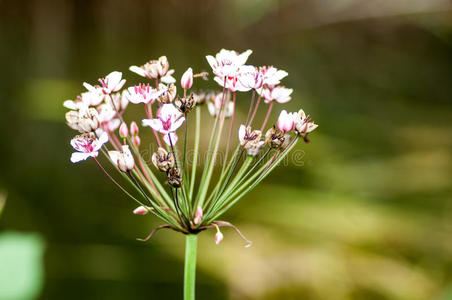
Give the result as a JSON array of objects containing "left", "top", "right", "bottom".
[{"left": 71, "top": 132, "right": 108, "bottom": 163}]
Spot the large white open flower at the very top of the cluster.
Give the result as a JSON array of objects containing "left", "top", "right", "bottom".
[{"left": 206, "top": 49, "right": 253, "bottom": 80}]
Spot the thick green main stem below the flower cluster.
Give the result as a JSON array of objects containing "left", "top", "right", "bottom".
[{"left": 184, "top": 234, "right": 198, "bottom": 300}]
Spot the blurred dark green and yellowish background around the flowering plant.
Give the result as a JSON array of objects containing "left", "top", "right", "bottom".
[{"left": 0, "top": 0, "right": 452, "bottom": 300}]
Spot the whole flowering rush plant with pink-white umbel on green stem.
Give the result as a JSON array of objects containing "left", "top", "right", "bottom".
[{"left": 64, "top": 49, "right": 317, "bottom": 299}]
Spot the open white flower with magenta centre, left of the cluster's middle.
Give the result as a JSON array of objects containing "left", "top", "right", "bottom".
[{"left": 143, "top": 103, "right": 185, "bottom": 134}]
